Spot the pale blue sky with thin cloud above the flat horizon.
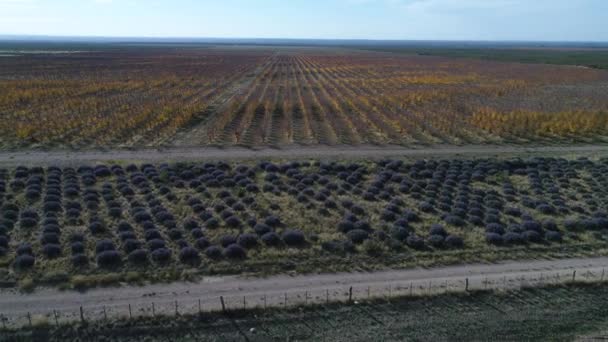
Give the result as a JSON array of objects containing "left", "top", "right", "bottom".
[{"left": 0, "top": 0, "right": 608, "bottom": 41}]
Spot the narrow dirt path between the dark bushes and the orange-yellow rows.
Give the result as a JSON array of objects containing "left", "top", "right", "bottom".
[{"left": 0, "top": 145, "right": 608, "bottom": 166}]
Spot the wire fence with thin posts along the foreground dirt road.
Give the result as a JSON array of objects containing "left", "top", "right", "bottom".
[{"left": 0, "top": 268, "right": 606, "bottom": 329}]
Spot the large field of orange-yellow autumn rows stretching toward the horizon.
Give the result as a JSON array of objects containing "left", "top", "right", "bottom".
[{"left": 0, "top": 47, "right": 608, "bottom": 149}]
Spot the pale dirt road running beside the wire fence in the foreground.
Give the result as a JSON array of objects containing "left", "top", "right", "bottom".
[{"left": 0, "top": 257, "right": 608, "bottom": 325}]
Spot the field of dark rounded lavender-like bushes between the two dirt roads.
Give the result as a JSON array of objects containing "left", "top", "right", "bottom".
[{"left": 0, "top": 157, "right": 608, "bottom": 287}]
